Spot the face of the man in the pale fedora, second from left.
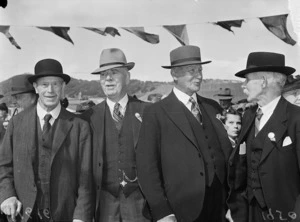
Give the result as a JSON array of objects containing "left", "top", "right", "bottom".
[{"left": 100, "top": 67, "right": 130, "bottom": 102}]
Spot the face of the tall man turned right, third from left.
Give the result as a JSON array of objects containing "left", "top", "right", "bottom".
[{"left": 173, "top": 65, "right": 202, "bottom": 96}]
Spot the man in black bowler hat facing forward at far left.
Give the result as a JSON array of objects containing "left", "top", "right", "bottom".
[{"left": 0, "top": 59, "right": 94, "bottom": 222}]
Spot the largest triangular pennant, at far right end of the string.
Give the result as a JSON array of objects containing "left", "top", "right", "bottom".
[{"left": 259, "top": 14, "right": 296, "bottom": 45}]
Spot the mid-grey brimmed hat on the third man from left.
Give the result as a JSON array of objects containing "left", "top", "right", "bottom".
[{"left": 162, "top": 45, "right": 211, "bottom": 69}]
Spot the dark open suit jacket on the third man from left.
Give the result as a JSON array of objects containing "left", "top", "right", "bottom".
[{"left": 137, "top": 92, "right": 232, "bottom": 221}]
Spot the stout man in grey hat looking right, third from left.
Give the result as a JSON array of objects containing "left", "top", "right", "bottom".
[{"left": 137, "top": 46, "right": 232, "bottom": 222}]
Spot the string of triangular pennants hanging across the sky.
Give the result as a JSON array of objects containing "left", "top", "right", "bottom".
[{"left": 0, "top": 14, "right": 296, "bottom": 49}]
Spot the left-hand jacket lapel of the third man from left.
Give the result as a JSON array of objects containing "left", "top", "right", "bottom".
[{"left": 162, "top": 91, "right": 199, "bottom": 149}]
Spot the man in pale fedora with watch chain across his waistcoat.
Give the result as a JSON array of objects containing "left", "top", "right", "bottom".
[{"left": 83, "top": 48, "right": 148, "bottom": 222}]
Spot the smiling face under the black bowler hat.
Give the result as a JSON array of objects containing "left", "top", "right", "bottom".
[{"left": 33, "top": 76, "right": 66, "bottom": 112}]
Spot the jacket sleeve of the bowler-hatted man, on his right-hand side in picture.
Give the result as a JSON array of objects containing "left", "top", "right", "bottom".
[{"left": 73, "top": 121, "right": 95, "bottom": 222}]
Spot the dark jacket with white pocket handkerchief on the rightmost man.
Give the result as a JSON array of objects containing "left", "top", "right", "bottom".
[{"left": 228, "top": 98, "right": 300, "bottom": 221}]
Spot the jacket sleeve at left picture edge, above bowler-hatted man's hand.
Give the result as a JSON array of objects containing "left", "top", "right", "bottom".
[{"left": 0, "top": 120, "right": 17, "bottom": 204}]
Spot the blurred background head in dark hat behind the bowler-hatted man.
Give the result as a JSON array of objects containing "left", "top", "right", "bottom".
[{"left": 6, "top": 74, "right": 38, "bottom": 113}]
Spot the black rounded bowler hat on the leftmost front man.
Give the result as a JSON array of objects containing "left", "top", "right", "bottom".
[{"left": 28, "top": 59, "right": 71, "bottom": 84}]
